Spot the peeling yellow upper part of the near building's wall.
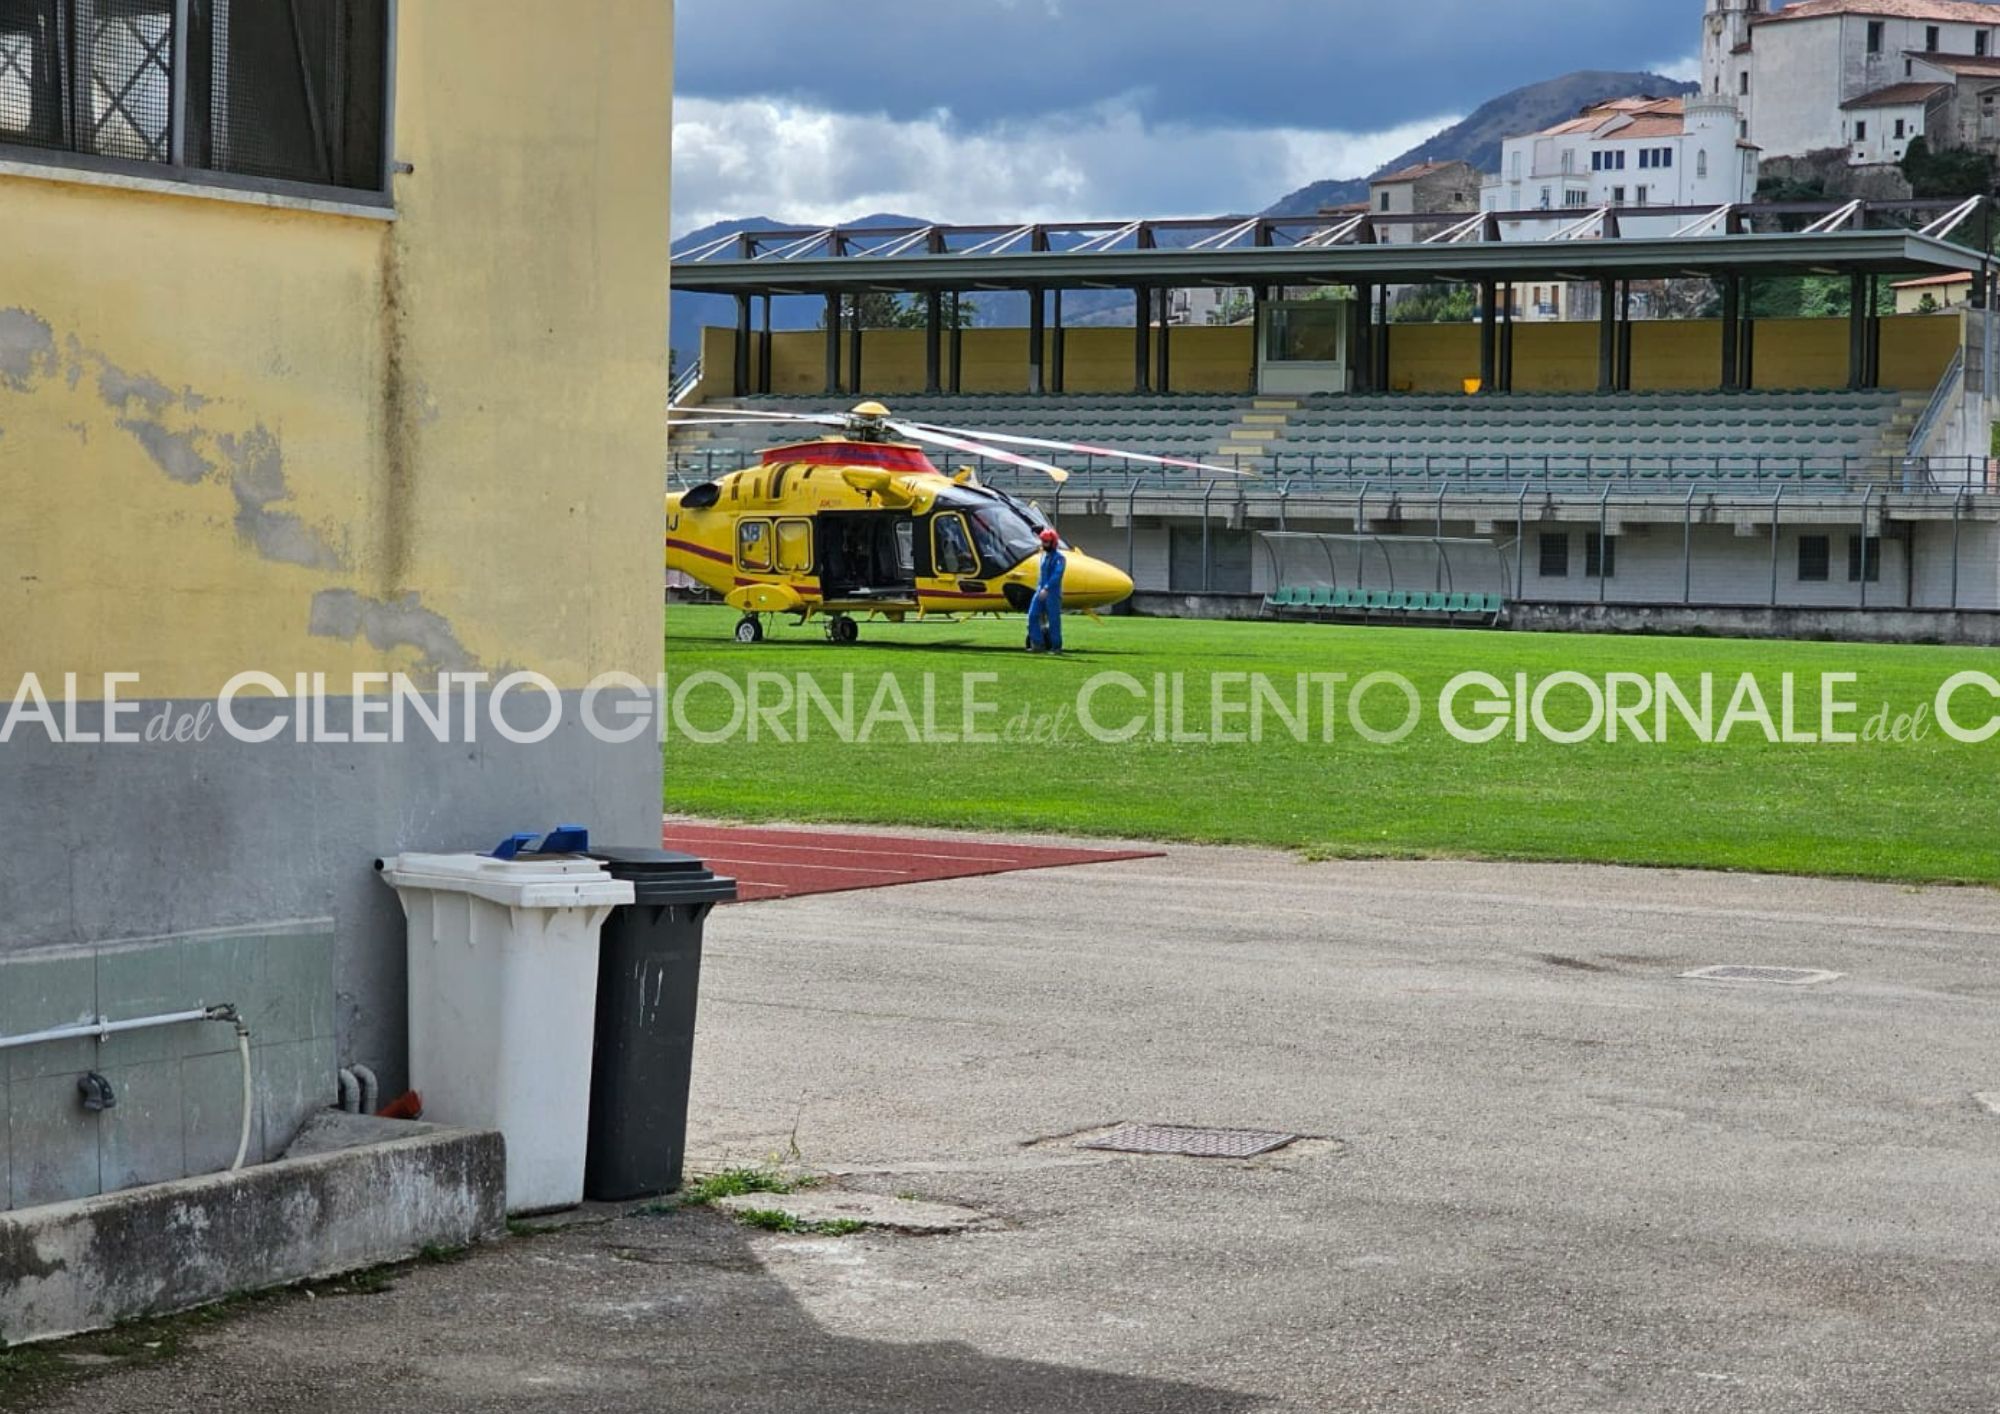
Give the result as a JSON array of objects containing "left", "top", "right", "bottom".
[{"left": 0, "top": 0, "right": 672, "bottom": 698}]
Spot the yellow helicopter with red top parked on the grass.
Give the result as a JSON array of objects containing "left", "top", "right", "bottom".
[{"left": 666, "top": 402, "right": 1230, "bottom": 644}]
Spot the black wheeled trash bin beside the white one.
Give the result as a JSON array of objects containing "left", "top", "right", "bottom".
[{"left": 584, "top": 846, "right": 736, "bottom": 1202}]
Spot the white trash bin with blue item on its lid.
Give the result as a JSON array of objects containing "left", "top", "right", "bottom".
[{"left": 376, "top": 854, "right": 632, "bottom": 1212}]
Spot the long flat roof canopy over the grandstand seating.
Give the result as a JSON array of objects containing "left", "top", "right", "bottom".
[{"left": 674, "top": 198, "right": 1988, "bottom": 296}]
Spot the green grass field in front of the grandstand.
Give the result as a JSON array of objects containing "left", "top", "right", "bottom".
[{"left": 666, "top": 606, "right": 2000, "bottom": 884}]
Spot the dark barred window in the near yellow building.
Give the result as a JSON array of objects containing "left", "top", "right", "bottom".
[{"left": 0, "top": 0, "right": 392, "bottom": 192}]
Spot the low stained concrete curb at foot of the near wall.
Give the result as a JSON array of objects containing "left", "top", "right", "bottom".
[{"left": 0, "top": 1126, "right": 506, "bottom": 1346}]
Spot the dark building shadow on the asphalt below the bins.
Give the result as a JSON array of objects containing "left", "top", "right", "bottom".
[{"left": 27, "top": 1212, "right": 1264, "bottom": 1414}]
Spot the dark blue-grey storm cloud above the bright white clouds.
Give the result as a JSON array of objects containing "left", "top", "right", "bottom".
[{"left": 676, "top": 0, "right": 1702, "bottom": 128}]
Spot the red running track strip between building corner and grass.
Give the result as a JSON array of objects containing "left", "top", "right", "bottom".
[{"left": 660, "top": 824, "right": 1160, "bottom": 904}]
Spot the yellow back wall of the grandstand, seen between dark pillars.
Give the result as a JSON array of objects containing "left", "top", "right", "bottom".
[{"left": 702, "top": 316, "right": 1960, "bottom": 402}]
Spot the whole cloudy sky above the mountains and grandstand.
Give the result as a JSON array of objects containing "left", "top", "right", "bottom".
[{"left": 674, "top": 0, "right": 1702, "bottom": 232}]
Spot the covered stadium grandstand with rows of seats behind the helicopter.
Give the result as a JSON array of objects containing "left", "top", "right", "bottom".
[{"left": 672, "top": 200, "right": 2000, "bottom": 636}]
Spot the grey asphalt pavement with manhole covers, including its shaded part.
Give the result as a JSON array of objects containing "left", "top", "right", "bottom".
[{"left": 39, "top": 848, "right": 2000, "bottom": 1414}]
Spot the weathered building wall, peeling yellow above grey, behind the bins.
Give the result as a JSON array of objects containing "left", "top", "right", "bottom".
[{"left": 0, "top": 0, "right": 672, "bottom": 1202}]
